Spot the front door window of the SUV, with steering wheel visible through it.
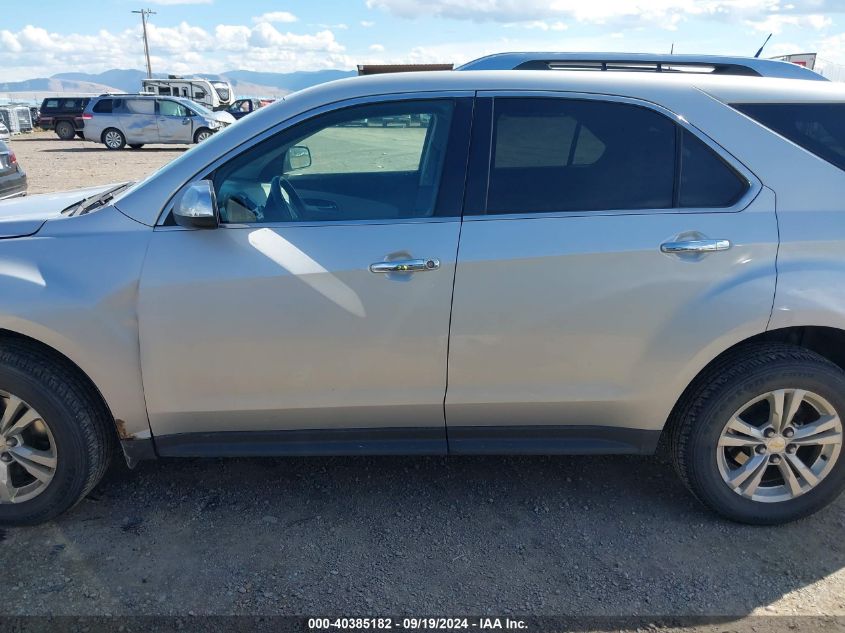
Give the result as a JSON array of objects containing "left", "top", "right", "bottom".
[{"left": 214, "top": 100, "right": 455, "bottom": 223}]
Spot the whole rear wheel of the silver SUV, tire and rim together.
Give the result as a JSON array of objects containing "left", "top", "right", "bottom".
[{"left": 668, "top": 343, "right": 845, "bottom": 525}]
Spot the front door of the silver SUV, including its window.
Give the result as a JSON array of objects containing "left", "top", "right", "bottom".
[{"left": 139, "top": 98, "right": 472, "bottom": 455}]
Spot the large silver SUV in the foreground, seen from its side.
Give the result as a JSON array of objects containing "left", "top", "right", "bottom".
[{"left": 0, "top": 53, "right": 845, "bottom": 524}]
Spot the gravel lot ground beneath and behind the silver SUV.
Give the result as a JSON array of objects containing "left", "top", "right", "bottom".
[{"left": 0, "top": 135, "right": 845, "bottom": 631}]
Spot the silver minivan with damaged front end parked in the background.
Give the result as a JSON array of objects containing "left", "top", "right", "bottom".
[{"left": 83, "top": 95, "right": 235, "bottom": 150}]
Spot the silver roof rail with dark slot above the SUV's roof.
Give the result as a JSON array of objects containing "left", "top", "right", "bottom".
[{"left": 455, "top": 52, "right": 827, "bottom": 81}]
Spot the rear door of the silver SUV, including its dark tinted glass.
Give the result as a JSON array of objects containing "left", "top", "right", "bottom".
[{"left": 446, "top": 94, "right": 778, "bottom": 453}]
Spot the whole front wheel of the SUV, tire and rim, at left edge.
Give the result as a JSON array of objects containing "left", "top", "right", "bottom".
[{"left": 0, "top": 341, "right": 114, "bottom": 525}]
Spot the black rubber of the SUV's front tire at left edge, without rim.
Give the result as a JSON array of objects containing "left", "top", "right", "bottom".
[{"left": 0, "top": 339, "right": 116, "bottom": 526}]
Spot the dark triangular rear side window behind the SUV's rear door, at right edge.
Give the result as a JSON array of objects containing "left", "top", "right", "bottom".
[{"left": 733, "top": 103, "right": 845, "bottom": 169}]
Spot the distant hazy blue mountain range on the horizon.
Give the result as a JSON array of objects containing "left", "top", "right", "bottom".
[{"left": 0, "top": 68, "right": 356, "bottom": 97}]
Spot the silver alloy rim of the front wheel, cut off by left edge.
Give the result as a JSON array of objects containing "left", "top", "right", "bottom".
[{"left": 0, "top": 391, "right": 58, "bottom": 504}]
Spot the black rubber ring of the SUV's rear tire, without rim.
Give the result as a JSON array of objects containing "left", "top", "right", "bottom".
[{"left": 668, "top": 343, "right": 845, "bottom": 525}]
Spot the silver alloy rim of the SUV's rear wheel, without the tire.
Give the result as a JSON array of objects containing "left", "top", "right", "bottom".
[{"left": 717, "top": 389, "right": 843, "bottom": 503}]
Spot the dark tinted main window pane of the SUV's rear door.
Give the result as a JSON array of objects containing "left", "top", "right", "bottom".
[{"left": 487, "top": 98, "right": 676, "bottom": 213}]
